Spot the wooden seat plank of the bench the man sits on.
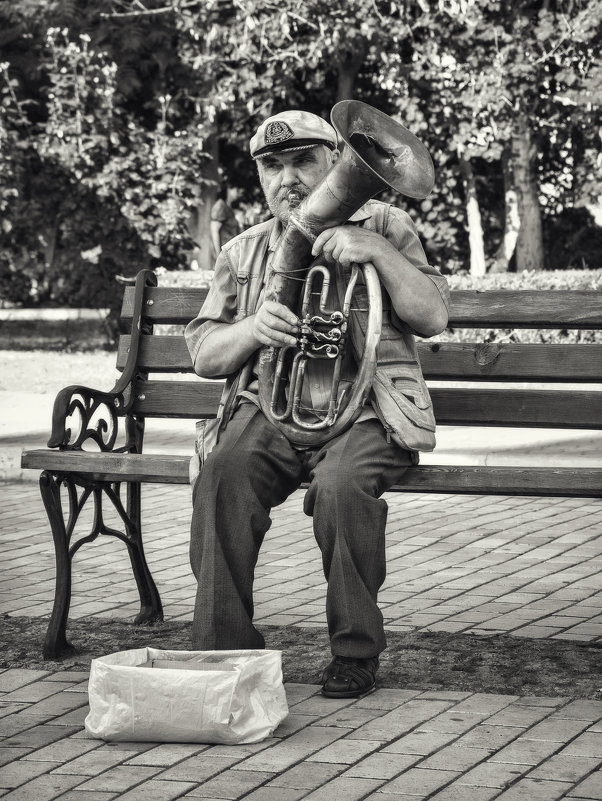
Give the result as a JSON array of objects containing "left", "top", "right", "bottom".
[{"left": 22, "top": 449, "right": 602, "bottom": 498}]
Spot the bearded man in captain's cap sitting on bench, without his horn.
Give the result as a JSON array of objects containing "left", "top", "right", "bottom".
[{"left": 186, "top": 106, "right": 449, "bottom": 698}]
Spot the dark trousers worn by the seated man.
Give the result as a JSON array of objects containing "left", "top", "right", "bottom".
[{"left": 190, "top": 402, "right": 411, "bottom": 658}]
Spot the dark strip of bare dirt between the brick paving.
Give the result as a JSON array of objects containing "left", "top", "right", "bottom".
[{"left": 0, "top": 616, "right": 602, "bottom": 700}]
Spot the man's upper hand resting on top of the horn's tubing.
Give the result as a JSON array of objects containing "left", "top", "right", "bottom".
[{"left": 312, "top": 225, "right": 397, "bottom": 267}]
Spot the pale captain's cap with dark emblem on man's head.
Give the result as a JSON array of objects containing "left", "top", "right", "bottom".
[{"left": 249, "top": 111, "right": 337, "bottom": 159}]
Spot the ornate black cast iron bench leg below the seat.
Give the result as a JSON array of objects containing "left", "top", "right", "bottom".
[{"left": 40, "top": 471, "right": 163, "bottom": 659}]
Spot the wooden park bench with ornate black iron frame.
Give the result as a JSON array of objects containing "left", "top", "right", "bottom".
[{"left": 22, "top": 271, "right": 602, "bottom": 658}]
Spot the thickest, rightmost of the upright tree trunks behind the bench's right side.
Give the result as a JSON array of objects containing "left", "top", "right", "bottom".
[{"left": 511, "top": 114, "right": 544, "bottom": 272}]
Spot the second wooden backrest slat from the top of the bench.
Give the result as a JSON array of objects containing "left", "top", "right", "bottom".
[{"left": 117, "top": 334, "right": 602, "bottom": 382}]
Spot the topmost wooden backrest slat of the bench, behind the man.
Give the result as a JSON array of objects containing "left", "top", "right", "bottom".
[{"left": 121, "top": 287, "right": 602, "bottom": 329}]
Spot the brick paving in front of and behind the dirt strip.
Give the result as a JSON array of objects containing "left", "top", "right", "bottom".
[{"left": 0, "top": 482, "right": 602, "bottom": 801}]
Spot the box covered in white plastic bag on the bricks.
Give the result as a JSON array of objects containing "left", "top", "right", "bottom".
[{"left": 85, "top": 648, "right": 288, "bottom": 744}]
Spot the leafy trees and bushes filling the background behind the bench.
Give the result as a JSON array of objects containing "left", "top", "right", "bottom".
[{"left": 0, "top": 0, "right": 602, "bottom": 306}]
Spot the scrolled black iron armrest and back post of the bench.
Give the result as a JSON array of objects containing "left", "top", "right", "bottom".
[{"left": 48, "top": 270, "right": 157, "bottom": 451}]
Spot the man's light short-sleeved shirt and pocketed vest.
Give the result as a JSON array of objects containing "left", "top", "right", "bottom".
[{"left": 186, "top": 200, "right": 449, "bottom": 451}]
